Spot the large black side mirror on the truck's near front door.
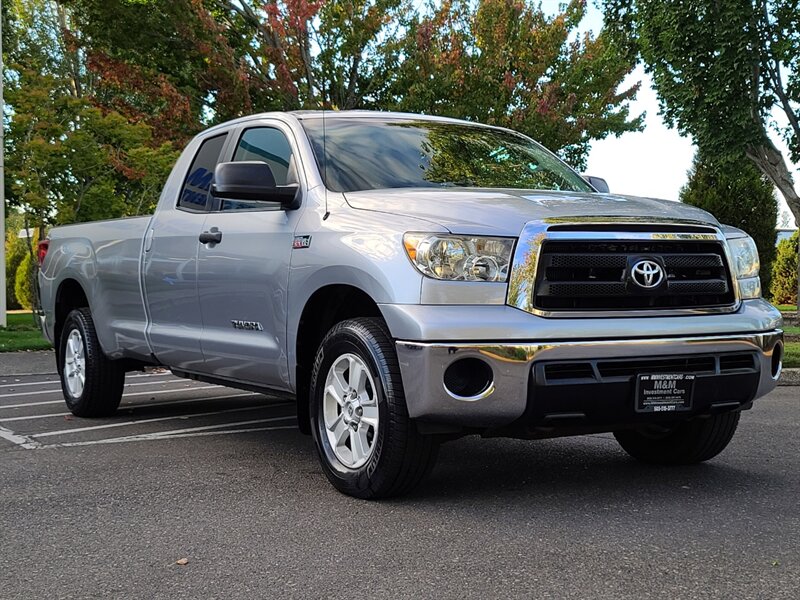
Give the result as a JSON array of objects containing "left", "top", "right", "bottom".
[{"left": 211, "top": 161, "right": 300, "bottom": 210}]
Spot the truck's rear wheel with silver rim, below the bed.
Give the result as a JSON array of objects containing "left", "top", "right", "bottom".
[{"left": 58, "top": 308, "right": 125, "bottom": 417}]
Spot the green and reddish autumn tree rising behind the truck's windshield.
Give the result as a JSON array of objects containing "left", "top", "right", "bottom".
[{"left": 394, "top": 0, "right": 641, "bottom": 168}]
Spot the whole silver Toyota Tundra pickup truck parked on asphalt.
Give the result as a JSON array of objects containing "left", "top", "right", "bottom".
[{"left": 39, "top": 112, "right": 783, "bottom": 498}]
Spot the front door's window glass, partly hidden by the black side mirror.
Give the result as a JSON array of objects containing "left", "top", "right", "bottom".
[{"left": 220, "top": 127, "right": 298, "bottom": 211}]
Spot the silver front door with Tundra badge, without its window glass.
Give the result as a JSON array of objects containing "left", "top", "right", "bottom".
[{"left": 197, "top": 121, "right": 306, "bottom": 389}]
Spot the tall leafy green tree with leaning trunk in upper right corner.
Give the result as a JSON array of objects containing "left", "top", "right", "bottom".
[{"left": 604, "top": 0, "right": 800, "bottom": 308}]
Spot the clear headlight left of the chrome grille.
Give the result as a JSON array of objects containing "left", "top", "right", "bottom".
[{"left": 403, "top": 233, "right": 514, "bottom": 281}]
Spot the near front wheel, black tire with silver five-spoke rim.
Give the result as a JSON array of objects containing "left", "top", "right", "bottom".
[{"left": 310, "top": 318, "right": 438, "bottom": 499}]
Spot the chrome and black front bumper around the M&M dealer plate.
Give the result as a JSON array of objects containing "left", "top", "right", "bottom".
[{"left": 397, "top": 329, "right": 783, "bottom": 430}]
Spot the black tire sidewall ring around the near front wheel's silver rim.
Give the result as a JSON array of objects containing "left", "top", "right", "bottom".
[{"left": 311, "top": 325, "right": 390, "bottom": 493}]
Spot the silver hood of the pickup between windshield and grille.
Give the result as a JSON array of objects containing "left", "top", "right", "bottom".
[{"left": 345, "top": 188, "right": 719, "bottom": 236}]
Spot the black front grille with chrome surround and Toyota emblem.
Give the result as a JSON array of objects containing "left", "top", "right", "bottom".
[{"left": 508, "top": 221, "right": 738, "bottom": 317}]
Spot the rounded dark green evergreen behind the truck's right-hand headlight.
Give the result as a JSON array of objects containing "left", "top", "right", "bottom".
[{"left": 680, "top": 153, "right": 778, "bottom": 290}]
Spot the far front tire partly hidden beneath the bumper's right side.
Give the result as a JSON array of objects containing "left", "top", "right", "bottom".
[{"left": 614, "top": 412, "right": 740, "bottom": 465}]
